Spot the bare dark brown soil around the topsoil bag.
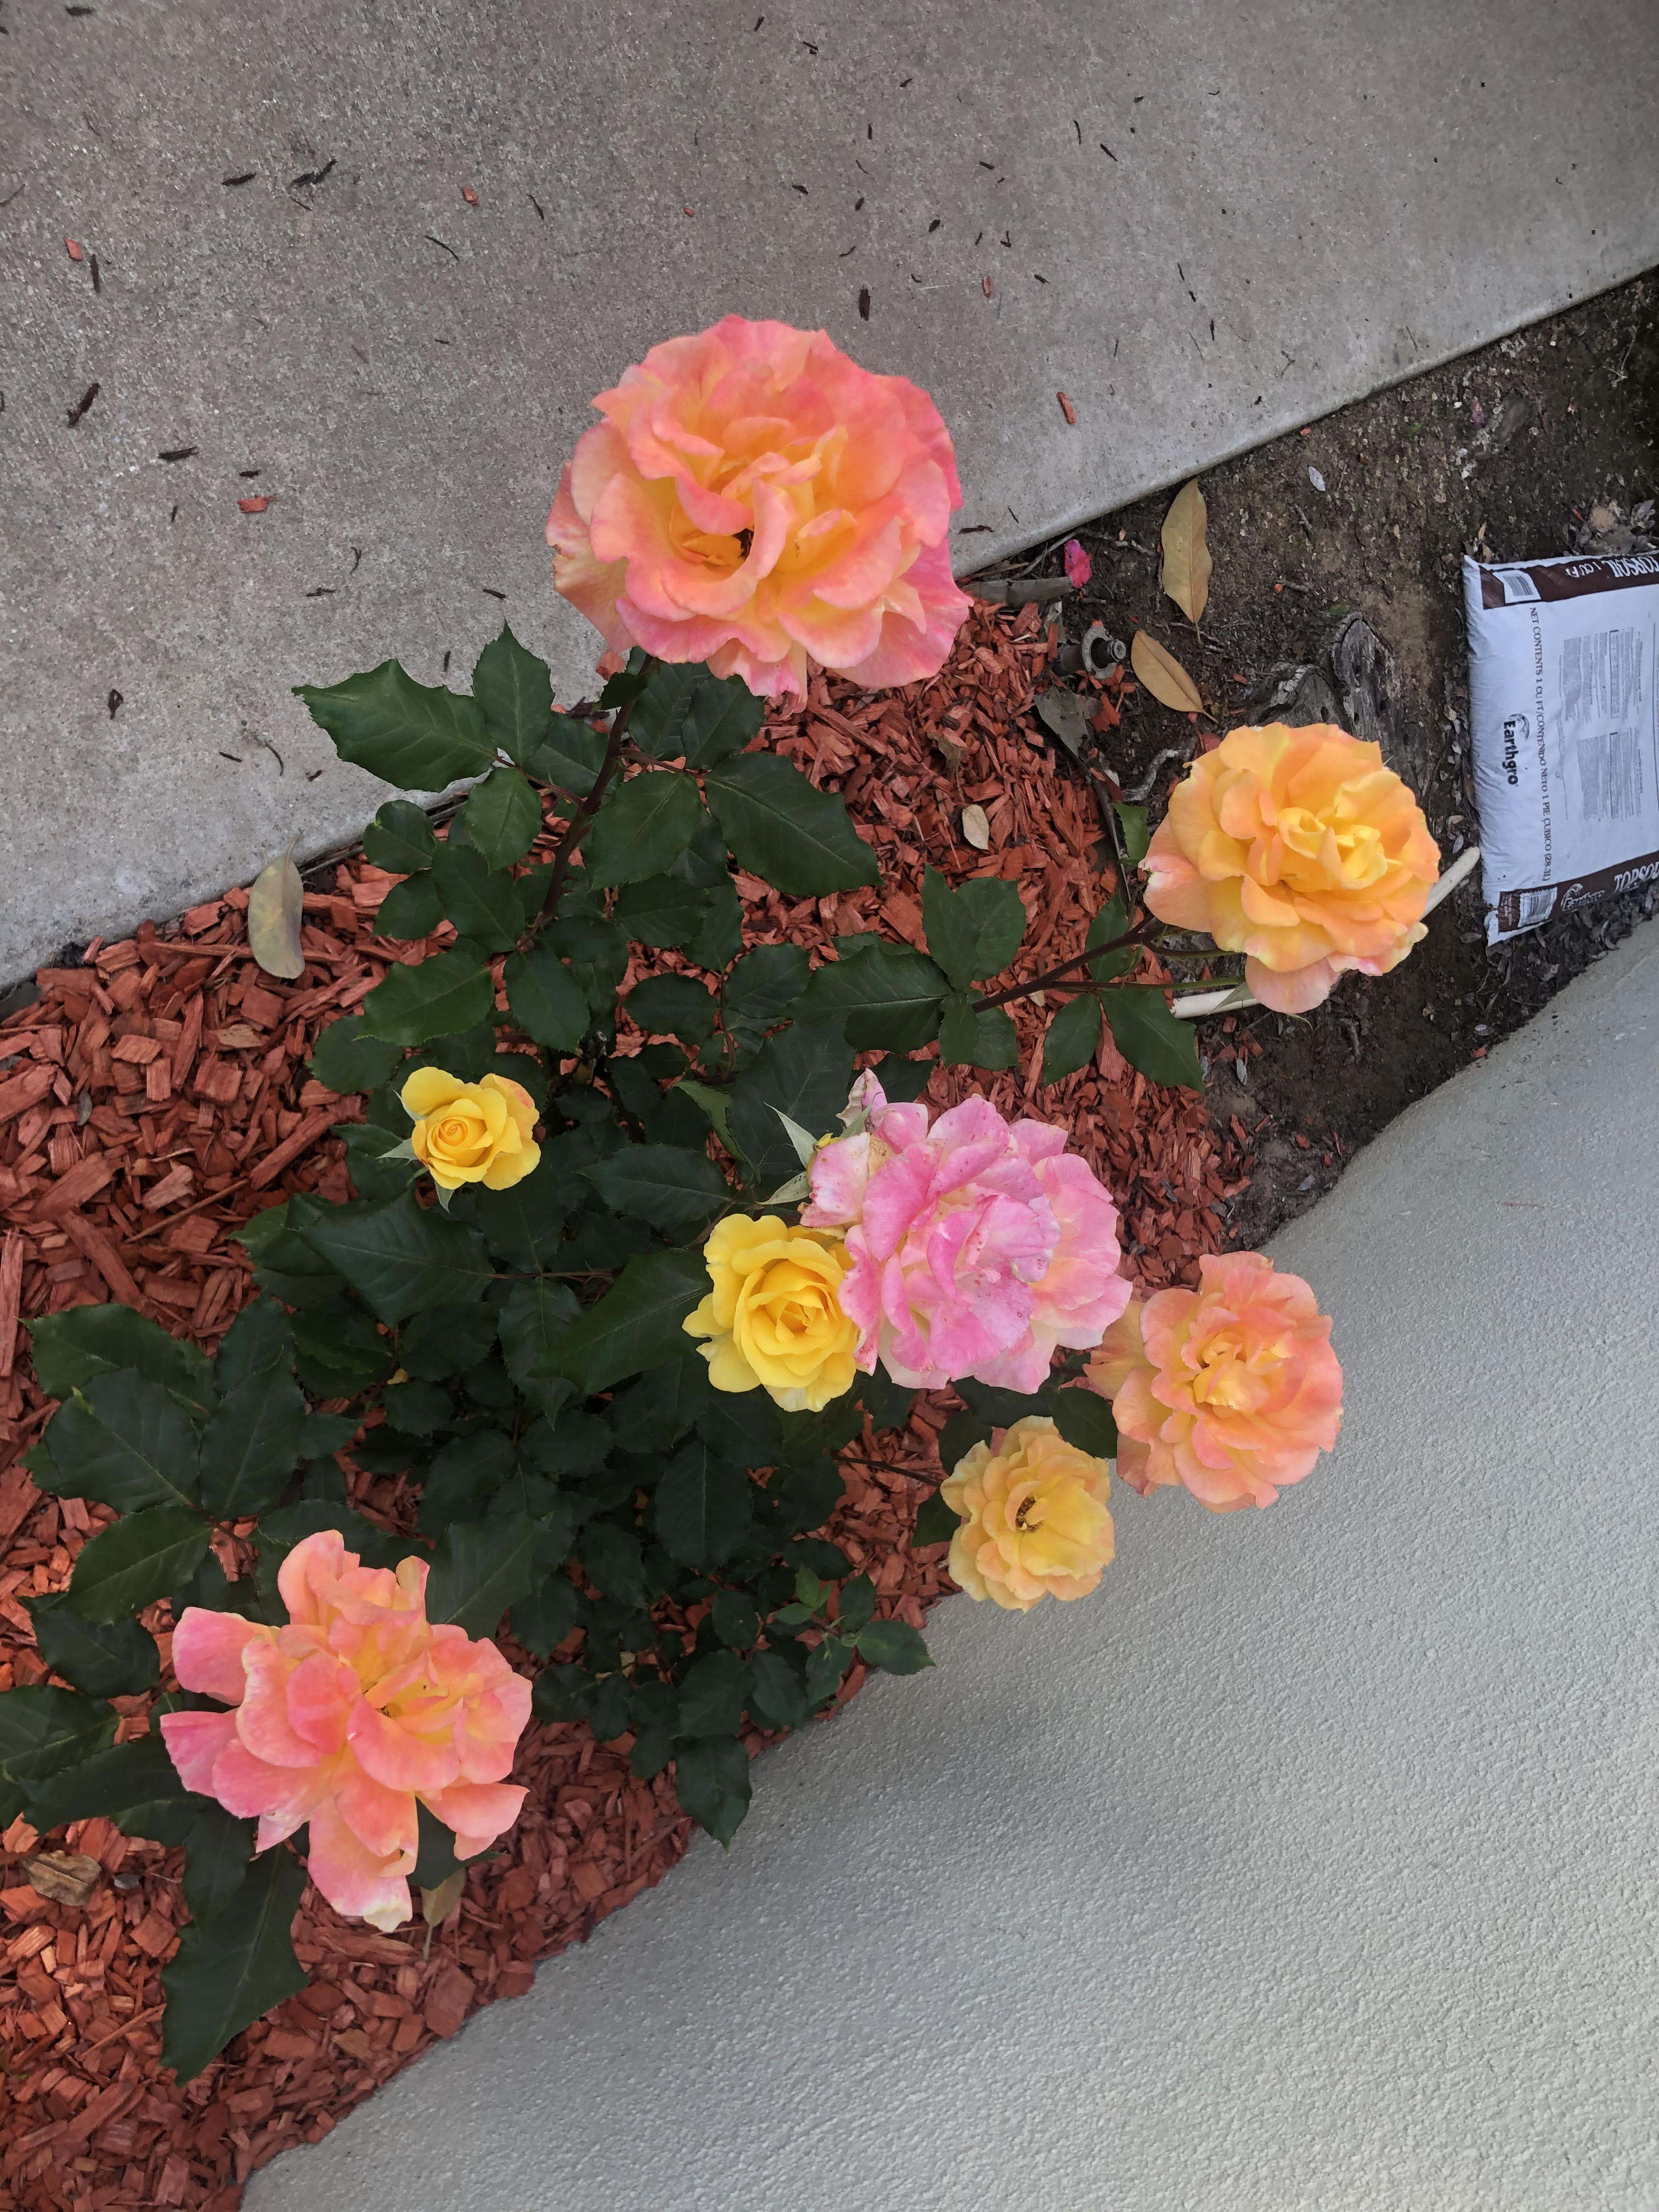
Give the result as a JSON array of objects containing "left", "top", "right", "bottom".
[{"left": 1000, "top": 274, "right": 1659, "bottom": 1245}]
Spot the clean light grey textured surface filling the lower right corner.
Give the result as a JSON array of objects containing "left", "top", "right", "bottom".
[{"left": 248, "top": 929, "right": 1659, "bottom": 2212}]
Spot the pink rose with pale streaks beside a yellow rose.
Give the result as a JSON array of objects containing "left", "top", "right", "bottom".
[{"left": 801, "top": 1073, "right": 1130, "bottom": 1393}]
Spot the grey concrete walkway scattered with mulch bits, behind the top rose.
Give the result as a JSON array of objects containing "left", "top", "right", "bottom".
[{"left": 0, "top": 0, "right": 1659, "bottom": 986}]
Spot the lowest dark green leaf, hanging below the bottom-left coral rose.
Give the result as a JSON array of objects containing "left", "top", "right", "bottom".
[{"left": 161, "top": 1845, "right": 305, "bottom": 2081}]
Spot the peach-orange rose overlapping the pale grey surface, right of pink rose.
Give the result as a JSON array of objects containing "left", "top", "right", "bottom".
[{"left": 1086, "top": 1252, "right": 1342, "bottom": 1513}]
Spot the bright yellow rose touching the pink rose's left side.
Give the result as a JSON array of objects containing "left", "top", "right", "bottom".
[{"left": 686, "top": 1215, "right": 858, "bottom": 1413}]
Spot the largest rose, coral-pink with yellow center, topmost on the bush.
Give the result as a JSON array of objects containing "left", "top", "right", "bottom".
[{"left": 546, "top": 314, "right": 969, "bottom": 699}]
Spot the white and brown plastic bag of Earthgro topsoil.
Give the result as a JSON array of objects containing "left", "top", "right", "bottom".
[{"left": 1462, "top": 553, "right": 1659, "bottom": 945}]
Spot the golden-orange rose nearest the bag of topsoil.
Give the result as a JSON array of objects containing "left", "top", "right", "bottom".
[{"left": 1146, "top": 723, "right": 1440, "bottom": 1013}]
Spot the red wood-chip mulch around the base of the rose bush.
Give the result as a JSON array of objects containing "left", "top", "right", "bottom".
[{"left": 0, "top": 608, "right": 1248, "bottom": 2212}]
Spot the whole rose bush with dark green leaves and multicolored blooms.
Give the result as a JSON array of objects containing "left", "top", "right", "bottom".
[{"left": 0, "top": 319, "right": 1380, "bottom": 2077}]
